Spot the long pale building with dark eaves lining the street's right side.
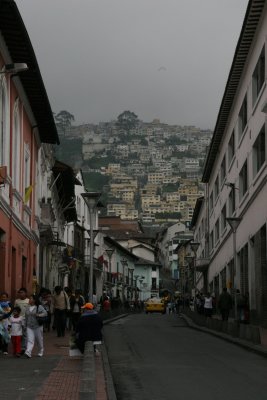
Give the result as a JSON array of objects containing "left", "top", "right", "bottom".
[{"left": 194, "top": 0, "right": 267, "bottom": 325}]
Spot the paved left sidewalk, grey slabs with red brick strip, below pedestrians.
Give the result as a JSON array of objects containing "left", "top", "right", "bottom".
[{"left": 0, "top": 331, "right": 108, "bottom": 400}]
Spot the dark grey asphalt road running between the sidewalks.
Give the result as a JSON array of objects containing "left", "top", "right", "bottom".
[{"left": 104, "top": 314, "right": 267, "bottom": 400}]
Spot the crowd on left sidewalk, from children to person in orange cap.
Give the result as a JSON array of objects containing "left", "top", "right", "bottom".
[{"left": 0, "top": 286, "right": 104, "bottom": 358}]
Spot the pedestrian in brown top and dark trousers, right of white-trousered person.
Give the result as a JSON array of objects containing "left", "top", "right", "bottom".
[{"left": 52, "top": 286, "right": 70, "bottom": 337}]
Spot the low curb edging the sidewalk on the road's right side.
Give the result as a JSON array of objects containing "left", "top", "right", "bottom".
[{"left": 181, "top": 314, "right": 267, "bottom": 358}]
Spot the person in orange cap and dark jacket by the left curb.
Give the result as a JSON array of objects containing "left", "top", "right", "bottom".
[{"left": 76, "top": 303, "right": 103, "bottom": 353}]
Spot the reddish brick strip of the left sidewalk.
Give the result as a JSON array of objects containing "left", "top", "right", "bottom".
[{"left": 36, "top": 332, "right": 107, "bottom": 400}]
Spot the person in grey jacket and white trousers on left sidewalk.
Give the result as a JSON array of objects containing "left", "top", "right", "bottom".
[{"left": 24, "top": 294, "right": 47, "bottom": 358}]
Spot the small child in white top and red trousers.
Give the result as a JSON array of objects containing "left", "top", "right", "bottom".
[{"left": 9, "top": 306, "right": 25, "bottom": 357}]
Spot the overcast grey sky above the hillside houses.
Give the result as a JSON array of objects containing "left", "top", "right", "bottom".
[{"left": 17, "top": 0, "right": 248, "bottom": 129}]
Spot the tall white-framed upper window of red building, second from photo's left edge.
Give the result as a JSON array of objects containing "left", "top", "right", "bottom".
[{"left": 12, "top": 100, "right": 21, "bottom": 191}]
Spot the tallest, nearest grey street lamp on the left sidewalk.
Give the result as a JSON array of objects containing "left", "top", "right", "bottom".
[{"left": 81, "top": 192, "right": 101, "bottom": 303}]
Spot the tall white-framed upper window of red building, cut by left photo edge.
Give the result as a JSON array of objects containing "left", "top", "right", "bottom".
[{"left": 0, "top": 77, "right": 10, "bottom": 171}]
